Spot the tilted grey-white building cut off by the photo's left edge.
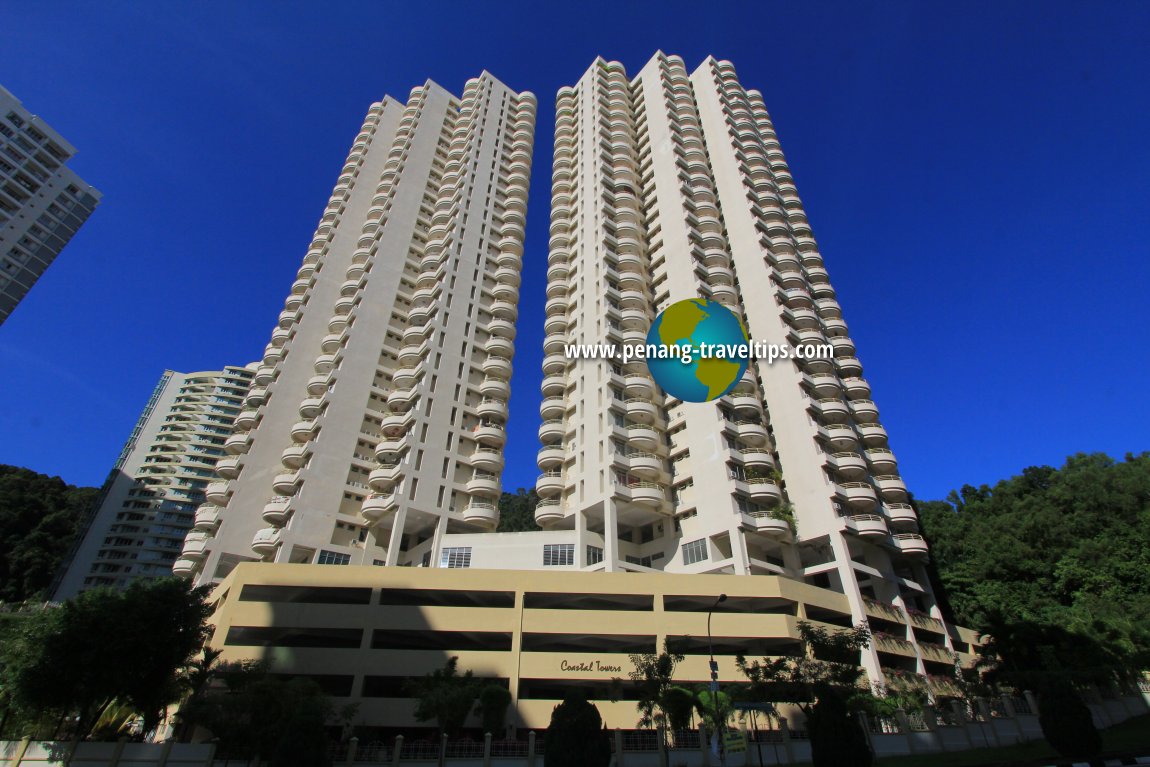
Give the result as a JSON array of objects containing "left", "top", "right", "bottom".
[{"left": 0, "top": 87, "right": 100, "bottom": 323}]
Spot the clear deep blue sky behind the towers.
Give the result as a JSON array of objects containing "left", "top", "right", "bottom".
[{"left": 0, "top": 0, "right": 1150, "bottom": 498}]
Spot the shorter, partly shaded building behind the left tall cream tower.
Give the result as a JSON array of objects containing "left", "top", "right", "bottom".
[{"left": 55, "top": 367, "right": 253, "bottom": 599}]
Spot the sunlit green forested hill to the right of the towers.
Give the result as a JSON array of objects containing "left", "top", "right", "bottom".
[{"left": 915, "top": 453, "right": 1150, "bottom": 666}]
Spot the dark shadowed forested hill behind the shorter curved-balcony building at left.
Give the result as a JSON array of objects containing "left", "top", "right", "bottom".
[{"left": 0, "top": 465, "right": 99, "bottom": 603}]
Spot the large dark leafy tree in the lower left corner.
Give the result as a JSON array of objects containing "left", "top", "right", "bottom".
[{"left": 0, "top": 578, "right": 209, "bottom": 736}]
